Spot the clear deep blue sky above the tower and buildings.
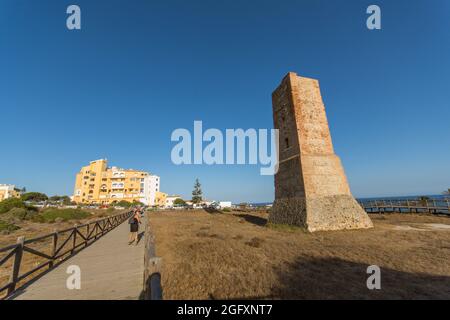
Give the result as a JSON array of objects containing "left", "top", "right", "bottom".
[{"left": 0, "top": 0, "right": 450, "bottom": 202}]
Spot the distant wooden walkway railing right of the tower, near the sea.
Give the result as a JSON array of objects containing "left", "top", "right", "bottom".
[{"left": 358, "top": 199, "right": 450, "bottom": 214}]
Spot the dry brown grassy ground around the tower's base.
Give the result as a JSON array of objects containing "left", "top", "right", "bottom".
[{"left": 150, "top": 211, "right": 450, "bottom": 299}]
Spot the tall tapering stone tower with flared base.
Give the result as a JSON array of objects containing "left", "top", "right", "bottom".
[{"left": 269, "top": 72, "right": 372, "bottom": 232}]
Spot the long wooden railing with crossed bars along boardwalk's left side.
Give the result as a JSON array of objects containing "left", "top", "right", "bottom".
[{"left": 0, "top": 212, "right": 132, "bottom": 299}]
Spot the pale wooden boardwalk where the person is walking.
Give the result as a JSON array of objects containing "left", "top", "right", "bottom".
[{"left": 11, "top": 218, "right": 147, "bottom": 300}]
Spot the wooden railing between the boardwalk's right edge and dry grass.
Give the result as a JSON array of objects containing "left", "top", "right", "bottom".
[{"left": 143, "top": 218, "right": 162, "bottom": 300}]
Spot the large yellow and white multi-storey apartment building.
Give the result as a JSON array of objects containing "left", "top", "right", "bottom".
[{"left": 73, "top": 159, "right": 161, "bottom": 206}]
